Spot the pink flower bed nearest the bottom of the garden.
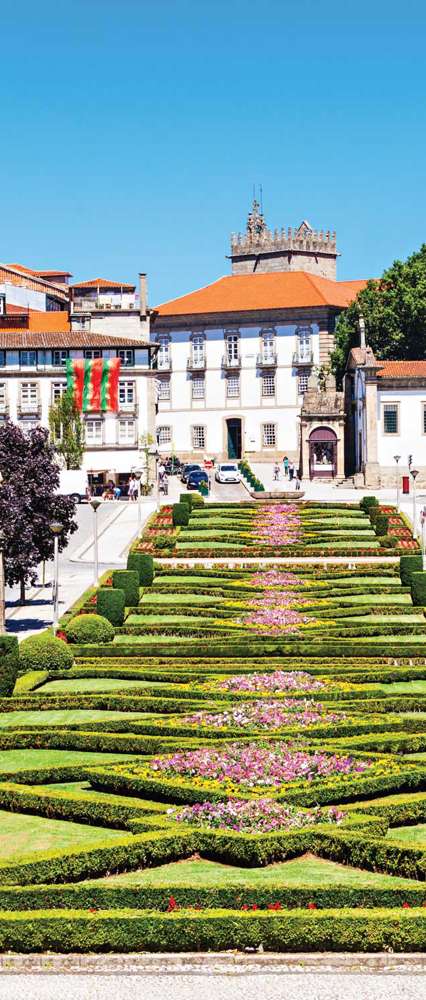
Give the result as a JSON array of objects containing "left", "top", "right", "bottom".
[{"left": 168, "top": 799, "right": 344, "bottom": 833}]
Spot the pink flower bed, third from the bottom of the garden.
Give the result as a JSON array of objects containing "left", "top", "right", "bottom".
[{"left": 183, "top": 698, "right": 346, "bottom": 729}]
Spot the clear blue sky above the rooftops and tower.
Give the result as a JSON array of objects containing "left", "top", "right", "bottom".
[{"left": 0, "top": 0, "right": 426, "bottom": 305}]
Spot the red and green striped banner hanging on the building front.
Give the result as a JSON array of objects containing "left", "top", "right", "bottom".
[{"left": 66, "top": 358, "right": 121, "bottom": 413}]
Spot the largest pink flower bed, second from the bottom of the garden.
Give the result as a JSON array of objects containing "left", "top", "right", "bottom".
[{"left": 150, "top": 743, "right": 371, "bottom": 790}]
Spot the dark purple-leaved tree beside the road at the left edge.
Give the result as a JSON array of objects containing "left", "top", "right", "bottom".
[{"left": 0, "top": 421, "right": 77, "bottom": 603}]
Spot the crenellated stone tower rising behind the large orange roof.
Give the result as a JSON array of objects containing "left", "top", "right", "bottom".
[{"left": 229, "top": 199, "right": 340, "bottom": 281}]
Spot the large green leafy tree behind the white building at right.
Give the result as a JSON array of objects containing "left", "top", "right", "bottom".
[{"left": 332, "top": 243, "right": 426, "bottom": 379}]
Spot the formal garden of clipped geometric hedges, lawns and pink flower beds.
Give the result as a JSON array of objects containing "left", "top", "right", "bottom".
[{"left": 0, "top": 499, "right": 426, "bottom": 952}]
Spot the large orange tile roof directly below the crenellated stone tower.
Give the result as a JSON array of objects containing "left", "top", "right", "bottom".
[{"left": 156, "top": 271, "right": 367, "bottom": 316}]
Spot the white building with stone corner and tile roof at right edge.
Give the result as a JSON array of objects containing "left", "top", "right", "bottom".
[{"left": 345, "top": 347, "right": 426, "bottom": 487}]
